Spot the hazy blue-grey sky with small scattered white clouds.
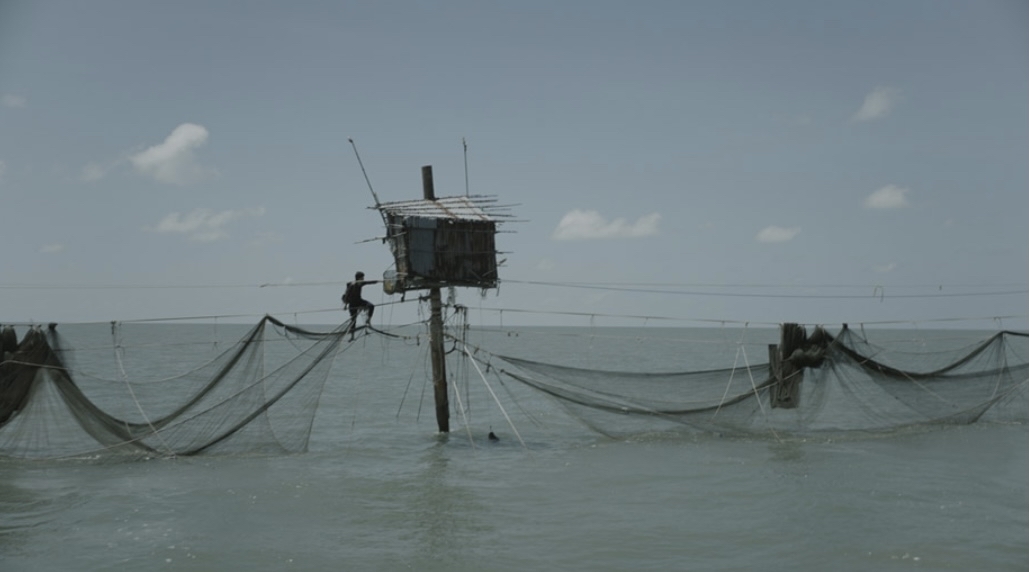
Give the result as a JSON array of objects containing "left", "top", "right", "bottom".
[{"left": 0, "top": 0, "right": 1029, "bottom": 329}]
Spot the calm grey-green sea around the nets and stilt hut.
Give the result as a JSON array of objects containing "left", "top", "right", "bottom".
[{"left": 0, "top": 324, "right": 1029, "bottom": 572}]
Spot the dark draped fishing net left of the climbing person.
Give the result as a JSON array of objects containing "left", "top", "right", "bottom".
[{"left": 0, "top": 316, "right": 350, "bottom": 459}]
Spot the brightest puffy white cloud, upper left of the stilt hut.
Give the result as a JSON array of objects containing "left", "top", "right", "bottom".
[{"left": 129, "top": 123, "right": 213, "bottom": 185}]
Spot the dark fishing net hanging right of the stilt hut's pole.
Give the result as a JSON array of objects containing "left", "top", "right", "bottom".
[{"left": 497, "top": 327, "right": 1029, "bottom": 436}]
